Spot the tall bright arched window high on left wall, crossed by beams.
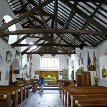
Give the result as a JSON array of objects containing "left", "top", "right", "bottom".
[{"left": 3, "top": 15, "right": 17, "bottom": 44}]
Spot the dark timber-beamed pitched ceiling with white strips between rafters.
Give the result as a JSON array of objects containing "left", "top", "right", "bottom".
[{"left": 0, "top": 0, "right": 107, "bottom": 55}]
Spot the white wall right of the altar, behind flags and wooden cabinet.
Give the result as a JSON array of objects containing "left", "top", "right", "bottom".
[{"left": 69, "top": 47, "right": 97, "bottom": 82}]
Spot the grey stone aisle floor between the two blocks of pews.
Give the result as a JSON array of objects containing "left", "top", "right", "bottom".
[{"left": 21, "top": 90, "right": 64, "bottom": 107}]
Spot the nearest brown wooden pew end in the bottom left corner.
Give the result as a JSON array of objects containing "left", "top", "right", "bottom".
[{"left": 0, "top": 93, "right": 11, "bottom": 107}]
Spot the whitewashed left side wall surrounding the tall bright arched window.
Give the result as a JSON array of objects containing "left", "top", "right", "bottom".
[{"left": 0, "top": 0, "right": 27, "bottom": 85}]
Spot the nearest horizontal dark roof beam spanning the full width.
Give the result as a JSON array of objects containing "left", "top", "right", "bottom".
[{"left": 0, "top": 29, "right": 107, "bottom": 36}]
